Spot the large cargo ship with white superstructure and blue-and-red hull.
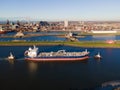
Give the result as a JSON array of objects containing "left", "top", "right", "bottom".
[{"left": 24, "top": 46, "right": 89, "bottom": 62}]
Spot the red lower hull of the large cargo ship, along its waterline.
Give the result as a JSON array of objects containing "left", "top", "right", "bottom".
[{"left": 25, "top": 56, "right": 89, "bottom": 62}]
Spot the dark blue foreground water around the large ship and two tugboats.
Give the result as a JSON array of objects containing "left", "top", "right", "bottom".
[{"left": 0, "top": 45, "right": 120, "bottom": 90}]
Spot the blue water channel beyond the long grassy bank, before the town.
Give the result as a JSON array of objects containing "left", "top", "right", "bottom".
[{"left": 0, "top": 32, "right": 120, "bottom": 41}]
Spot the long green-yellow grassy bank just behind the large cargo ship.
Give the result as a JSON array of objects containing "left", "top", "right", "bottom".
[{"left": 0, "top": 41, "right": 120, "bottom": 48}]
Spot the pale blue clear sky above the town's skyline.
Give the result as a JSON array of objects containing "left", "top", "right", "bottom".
[{"left": 0, "top": 0, "right": 120, "bottom": 21}]
